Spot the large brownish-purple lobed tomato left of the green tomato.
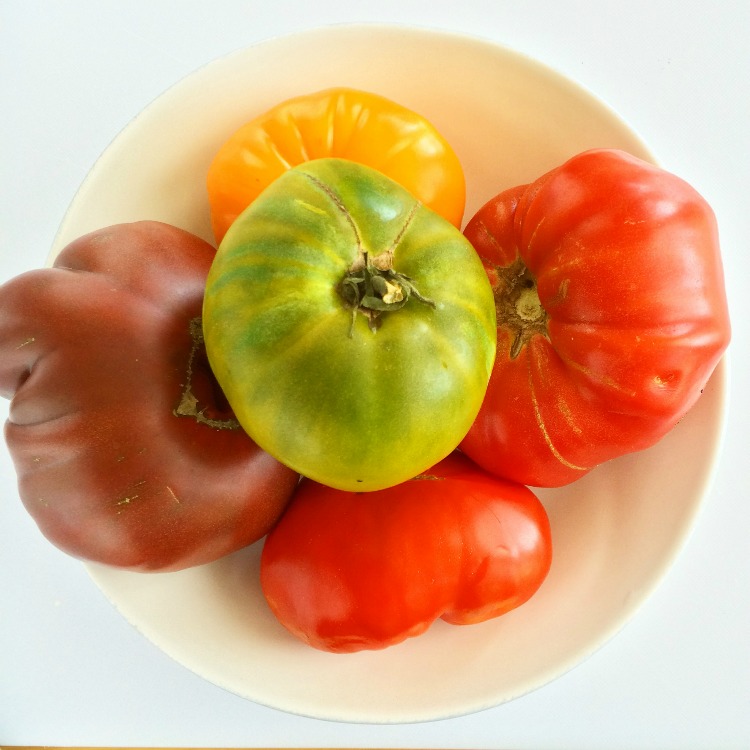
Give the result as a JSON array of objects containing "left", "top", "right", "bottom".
[{"left": 0, "top": 222, "right": 298, "bottom": 572}]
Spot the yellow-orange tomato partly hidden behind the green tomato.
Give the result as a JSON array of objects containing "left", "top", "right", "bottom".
[{"left": 207, "top": 87, "right": 466, "bottom": 242}]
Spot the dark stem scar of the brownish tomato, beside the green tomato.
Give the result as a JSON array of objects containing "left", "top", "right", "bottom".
[{"left": 172, "top": 317, "right": 240, "bottom": 430}]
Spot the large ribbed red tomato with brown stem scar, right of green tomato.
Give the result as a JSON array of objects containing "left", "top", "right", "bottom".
[{"left": 461, "top": 149, "right": 730, "bottom": 487}]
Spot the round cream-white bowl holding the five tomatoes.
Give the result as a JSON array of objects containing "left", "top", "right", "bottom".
[{"left": 53, "top": 26, "right": 726, "bottom": 723}]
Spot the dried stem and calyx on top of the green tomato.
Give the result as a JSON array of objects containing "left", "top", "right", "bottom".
[{"left": 338, "top": 251, "right": 435, "bottom": 338}]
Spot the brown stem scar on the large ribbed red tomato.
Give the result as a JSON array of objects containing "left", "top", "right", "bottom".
[{"left": 492, "top": 257, "right": 548, "bottom": 359}]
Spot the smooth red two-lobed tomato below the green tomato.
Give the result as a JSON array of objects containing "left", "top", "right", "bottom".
[{"left": 260, "top": 453, "right": 552, "bottom": 653}]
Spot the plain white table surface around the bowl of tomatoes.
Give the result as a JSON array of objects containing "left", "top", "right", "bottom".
[{"left": 0, "top": 0, "right": 750, "bottom": 750}]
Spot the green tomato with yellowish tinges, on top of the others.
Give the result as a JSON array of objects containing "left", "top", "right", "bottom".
[{"left": 203, "top": 158, "right": 496, "bottom": 491}]
